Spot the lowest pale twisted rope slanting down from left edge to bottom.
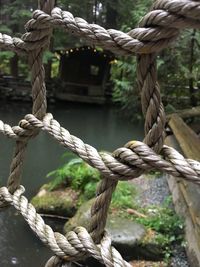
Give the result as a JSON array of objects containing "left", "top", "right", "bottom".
[{"left": 0, "top": 186, "right": 130, "bottom": 267}]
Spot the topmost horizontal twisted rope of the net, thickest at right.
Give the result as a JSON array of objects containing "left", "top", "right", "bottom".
[{"left": 0, "top": 0, "right": 200, "bottom": 54}]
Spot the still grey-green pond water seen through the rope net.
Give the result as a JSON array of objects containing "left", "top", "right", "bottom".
[{"left": 0, "top": 103, "right": 143, "bottom": 267}]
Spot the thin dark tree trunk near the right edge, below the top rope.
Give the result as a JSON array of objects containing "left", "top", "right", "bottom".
[{"left": 189, "top": 30, "right": 197, "bottom": 106}]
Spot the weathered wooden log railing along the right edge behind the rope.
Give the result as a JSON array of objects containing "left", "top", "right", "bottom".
[{"left": 166, "top": 114, "right": 200, "bottom": 267}]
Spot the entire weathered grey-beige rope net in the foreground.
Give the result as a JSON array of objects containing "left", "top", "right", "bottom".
[{"left": 0, "top": 0, "right": 200, "bottom": 267}]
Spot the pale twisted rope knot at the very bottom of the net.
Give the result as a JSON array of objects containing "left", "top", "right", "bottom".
[{"left": 45, "top": 227, "right": 130, "bottom": 267}]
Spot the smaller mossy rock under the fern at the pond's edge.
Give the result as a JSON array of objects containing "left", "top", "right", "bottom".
[{"left": 31, "top": 185, "right": 78, "bottom": 218}]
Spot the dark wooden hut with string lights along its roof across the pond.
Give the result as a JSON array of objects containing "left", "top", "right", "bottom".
[{"left": 55, "top": 46, "right": 114, "bottom": 104}]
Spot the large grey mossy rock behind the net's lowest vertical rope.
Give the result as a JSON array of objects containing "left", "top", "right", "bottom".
[{"left": 64, "top": 199, "right": 163, "bottom": 260}]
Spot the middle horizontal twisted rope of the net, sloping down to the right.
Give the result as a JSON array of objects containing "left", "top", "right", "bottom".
[{"left": 0, "top": 113, "right": 200, "bottom": 184}]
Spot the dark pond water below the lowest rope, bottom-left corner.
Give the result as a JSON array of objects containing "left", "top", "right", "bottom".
[{"left": 0, "top": 208, "right": 51, "bottom": 267}]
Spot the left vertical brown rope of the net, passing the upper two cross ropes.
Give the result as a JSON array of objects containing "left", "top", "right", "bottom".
[{"left": 5, "top": 0, "right": 54, "bottom": 200}]
